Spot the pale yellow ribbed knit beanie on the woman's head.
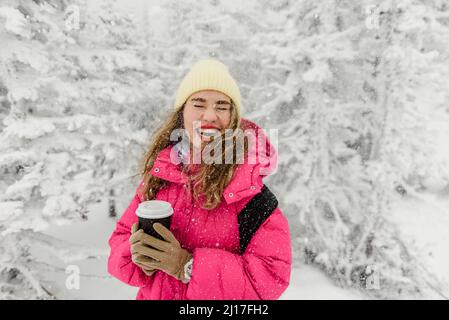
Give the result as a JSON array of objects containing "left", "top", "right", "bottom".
[{"left": 174, "top": 59, "right": 241, "bottom": 114}]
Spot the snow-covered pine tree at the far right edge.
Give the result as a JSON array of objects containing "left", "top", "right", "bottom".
[{"left": 374, "top": 0, "right": 449, "bottom": 197}]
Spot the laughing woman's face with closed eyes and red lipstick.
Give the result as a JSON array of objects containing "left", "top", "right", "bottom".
[{"left": 183, "top": 90, "right": 231, "bottom": 147}]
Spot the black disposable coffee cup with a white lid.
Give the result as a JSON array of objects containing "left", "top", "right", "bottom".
[{"left": 136, "top": 200, "right": 173, "bottom": 240}]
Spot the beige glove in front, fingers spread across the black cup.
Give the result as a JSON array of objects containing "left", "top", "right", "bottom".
[{"left": 130, "top": 223, "right": 192, "bottom": 281}]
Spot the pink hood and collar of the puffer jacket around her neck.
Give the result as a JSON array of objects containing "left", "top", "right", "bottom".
[{"left": 146, "top": 119, "right": 277, "bottom": 204}]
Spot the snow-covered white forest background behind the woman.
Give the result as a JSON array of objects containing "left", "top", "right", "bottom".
[{"left": 0, "top": 0, "right": 449, "bottom": 299}]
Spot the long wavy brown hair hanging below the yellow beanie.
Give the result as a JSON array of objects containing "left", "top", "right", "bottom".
[{"left": 134, "top": 100, "right": 248, "bottom": 209}]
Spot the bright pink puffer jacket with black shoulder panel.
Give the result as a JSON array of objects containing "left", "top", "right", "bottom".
[{"left": 108, "top": 120, "right": 291, "bottom": 300}]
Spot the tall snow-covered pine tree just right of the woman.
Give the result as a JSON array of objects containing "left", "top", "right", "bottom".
[{"left": 242, "top": 1, "right": 447, "bottom": 297}]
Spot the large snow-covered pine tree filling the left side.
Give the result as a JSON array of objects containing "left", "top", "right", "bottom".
[{"left": 0, "top": 0, "right": 149, "bottom": 298}]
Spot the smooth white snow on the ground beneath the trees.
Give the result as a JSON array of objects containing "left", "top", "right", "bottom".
[{"left": 34, "top": 195, "right": 449, "bottom": 300}]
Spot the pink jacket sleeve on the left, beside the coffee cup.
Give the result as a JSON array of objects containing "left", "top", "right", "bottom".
[{"left": 108, "top": 185, "right": 153, "bottom": 287}]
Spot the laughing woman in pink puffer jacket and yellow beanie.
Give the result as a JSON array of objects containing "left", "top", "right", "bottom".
[{"left": 108, "top": 59, "right": 291, "bottom": 300}]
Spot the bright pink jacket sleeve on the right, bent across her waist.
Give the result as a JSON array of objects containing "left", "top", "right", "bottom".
[{"left": 186, "top": 208, "right": 291, "bottom": 300}]
